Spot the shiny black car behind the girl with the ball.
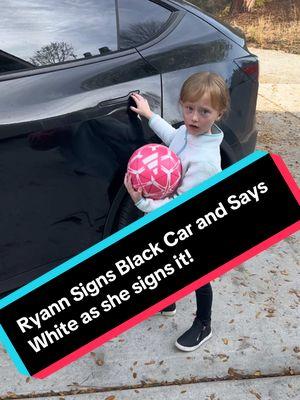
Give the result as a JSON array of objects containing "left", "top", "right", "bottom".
[{"left": 0, "top": 0, "right": 258, "bottom": 295}]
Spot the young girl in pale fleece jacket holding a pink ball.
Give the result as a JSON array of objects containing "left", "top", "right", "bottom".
[{"left": 124, "top": 72, "right": 229, "bottom": 351}]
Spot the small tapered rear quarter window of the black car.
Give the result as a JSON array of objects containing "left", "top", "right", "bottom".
[{"left": 118, "top": 0, "right": 171, "bottom": 50}]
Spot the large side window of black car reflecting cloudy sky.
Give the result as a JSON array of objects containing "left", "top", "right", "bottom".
[{"left": 0, "top": 0, "right": 117, "bottom": 72}]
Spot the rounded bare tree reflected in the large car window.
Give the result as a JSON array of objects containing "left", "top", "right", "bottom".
[{"left": 30, "top": 42, "right": 76, "bottom": 66}]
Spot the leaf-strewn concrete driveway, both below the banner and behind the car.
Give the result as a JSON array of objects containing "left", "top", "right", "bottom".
[{"left": 0, "top": 49, "right": 300, "bottom": 400}]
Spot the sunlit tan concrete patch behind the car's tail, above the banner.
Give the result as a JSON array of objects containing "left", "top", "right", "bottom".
[{"left": 250, "top": 49, "right": 300, "bottom": 184}]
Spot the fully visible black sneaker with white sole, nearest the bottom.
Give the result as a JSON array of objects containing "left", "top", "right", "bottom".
[{"left": 175, "top": 318, "right": 212, "bottom": 351}]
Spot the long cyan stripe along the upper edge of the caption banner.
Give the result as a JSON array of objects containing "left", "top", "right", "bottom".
[{"left": 0, "top": 150, "right": 268, "bottom": 309}]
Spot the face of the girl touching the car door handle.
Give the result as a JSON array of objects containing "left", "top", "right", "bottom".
[{"left": 180, "top": 94, "right": 222, "bottom": 136}]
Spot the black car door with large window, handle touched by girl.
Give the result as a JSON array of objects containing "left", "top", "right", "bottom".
[{"left": 0, "top": 0, "right": 176, "bottom": 292}]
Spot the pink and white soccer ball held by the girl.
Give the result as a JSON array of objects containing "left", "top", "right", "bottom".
[{"left": 127, "top": 143, "right": 181, "bottom": 199}]
